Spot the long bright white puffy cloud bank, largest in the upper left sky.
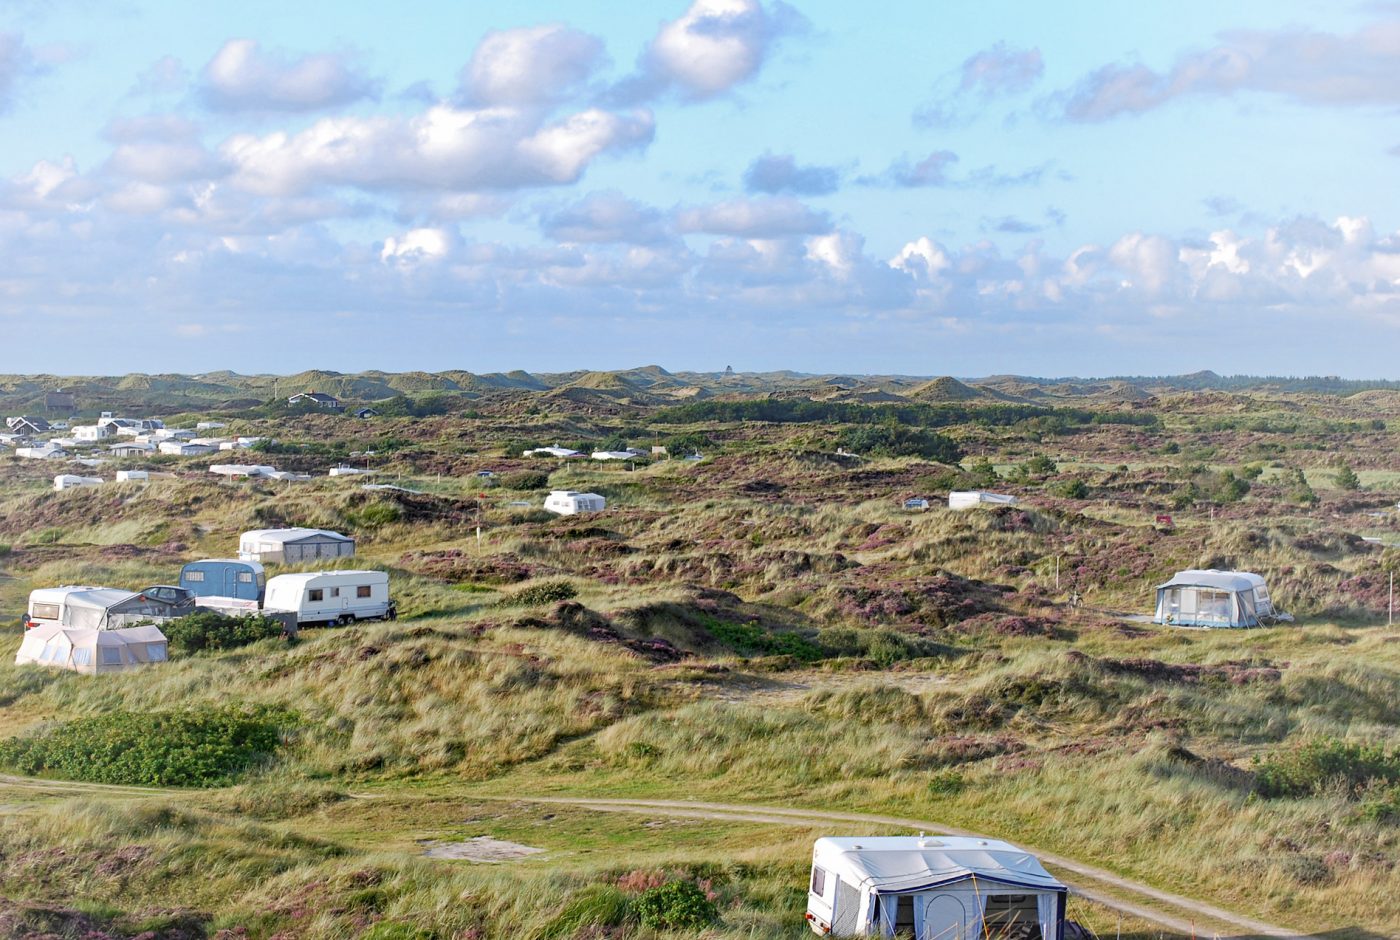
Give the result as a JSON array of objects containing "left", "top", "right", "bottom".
[{"left": 220, "top": 104, "right": 654, "bottom": 195}]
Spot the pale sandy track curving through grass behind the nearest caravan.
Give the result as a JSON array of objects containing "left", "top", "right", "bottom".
[{"left": 498, "top": 794, "right": 1306, "bottom": 937}]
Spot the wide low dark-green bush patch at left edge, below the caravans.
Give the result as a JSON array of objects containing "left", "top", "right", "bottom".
[{"left": 0, "top": 706, "right": 295, "bottom": 787}]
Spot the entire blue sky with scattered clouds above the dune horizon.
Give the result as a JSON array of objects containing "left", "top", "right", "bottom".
[{"left": 0, "top": 0, "right": 1400, "bottom": 378}]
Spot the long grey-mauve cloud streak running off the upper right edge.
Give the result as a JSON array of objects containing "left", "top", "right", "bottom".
[{"left": 1053, "top": 20, "right": 1400, "bottom": 122}]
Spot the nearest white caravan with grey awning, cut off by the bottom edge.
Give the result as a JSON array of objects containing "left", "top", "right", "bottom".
[{"left": 806, "top": 836, "right": 1068, "bottom": 940}]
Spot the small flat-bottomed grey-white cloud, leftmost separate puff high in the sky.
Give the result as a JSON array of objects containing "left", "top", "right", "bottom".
[{"left": 200, "top": 39, "right": 375, "bottom": 112}]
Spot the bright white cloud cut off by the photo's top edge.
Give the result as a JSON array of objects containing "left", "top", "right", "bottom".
[{"left": 615, "top": 0, "right": 806, "bottom": 101}]
